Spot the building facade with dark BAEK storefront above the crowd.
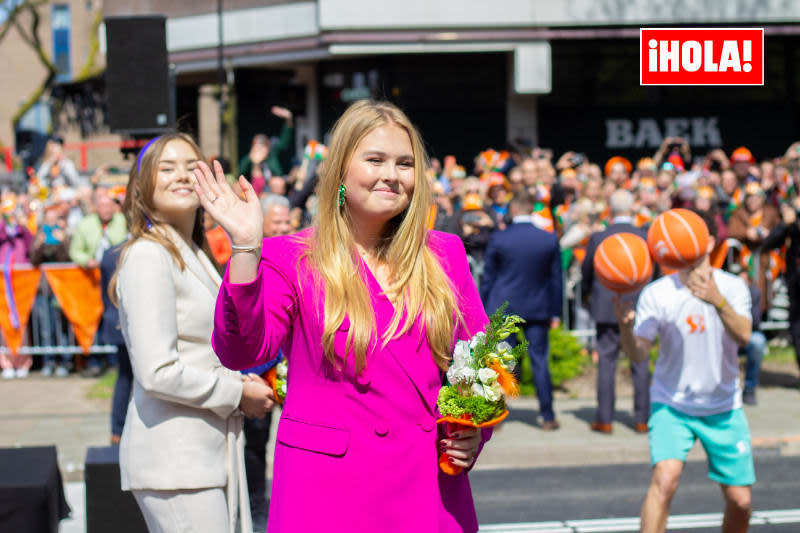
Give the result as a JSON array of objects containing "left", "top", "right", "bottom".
[{"left": 100, "top": 0, "right": 800, "bottom": 168}]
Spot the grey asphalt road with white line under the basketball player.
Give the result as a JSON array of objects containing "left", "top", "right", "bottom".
[{"left": 470, "top": 456, "right": 800, "bottom": 533}]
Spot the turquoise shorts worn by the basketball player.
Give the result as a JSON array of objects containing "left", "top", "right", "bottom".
[{"left": 648, "top": 403, "right": 756, "bottom": 486}]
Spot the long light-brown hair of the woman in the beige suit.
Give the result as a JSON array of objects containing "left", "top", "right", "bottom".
[{"left": 108, "top": 133, "right": 213, "bottom": 305}]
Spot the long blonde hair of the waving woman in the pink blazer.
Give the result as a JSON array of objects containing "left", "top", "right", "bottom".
[{"left": 303, "top": 100, "right": 462, "bottom": 371}]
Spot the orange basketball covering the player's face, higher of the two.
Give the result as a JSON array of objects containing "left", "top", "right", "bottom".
[{"left": 647, "top": 209, "right": 709, "bottom": 270}]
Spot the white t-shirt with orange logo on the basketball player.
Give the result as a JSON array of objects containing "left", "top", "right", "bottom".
[{"left": 634, "top": 269, "right": 751, "bottom": 416}]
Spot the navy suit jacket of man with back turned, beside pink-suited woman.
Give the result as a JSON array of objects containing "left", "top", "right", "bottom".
[{"left": 480, "top": 222, "right": 564, "bottom": 321}]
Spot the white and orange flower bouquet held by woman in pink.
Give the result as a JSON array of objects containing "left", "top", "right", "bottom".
[{"left": 436, "top": 303, "right": 528, "bottom": 475}]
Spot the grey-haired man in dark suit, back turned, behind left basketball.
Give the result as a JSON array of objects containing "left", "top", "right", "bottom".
[{"left": 581, "top": 189, "right": 650, "bottom": 433}]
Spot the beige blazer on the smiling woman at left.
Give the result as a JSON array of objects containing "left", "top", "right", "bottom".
[{"left": 117, "top": 228, "right": 252, "bottom": 531}]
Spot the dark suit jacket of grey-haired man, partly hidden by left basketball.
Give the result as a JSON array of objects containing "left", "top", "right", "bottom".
[{"left": 581, "top": 223, "right": 647, "bottom": 325}]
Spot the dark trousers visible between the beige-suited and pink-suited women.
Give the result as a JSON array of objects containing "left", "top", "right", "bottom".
[{"left": 244, "top": 412, "right": 272, "bottom": 531}]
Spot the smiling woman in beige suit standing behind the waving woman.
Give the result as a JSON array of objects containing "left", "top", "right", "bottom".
[{"left": 109, "top": 134, "right": 272, "bottom": 533}]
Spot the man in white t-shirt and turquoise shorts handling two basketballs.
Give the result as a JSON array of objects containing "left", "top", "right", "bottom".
[{"left": 614, "top": 215, "right": 756, "bottom": 533}]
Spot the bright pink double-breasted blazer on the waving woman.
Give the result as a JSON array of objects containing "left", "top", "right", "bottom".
[{"left": 212, "top": 230, "right": 491, "bottom": 533}]
